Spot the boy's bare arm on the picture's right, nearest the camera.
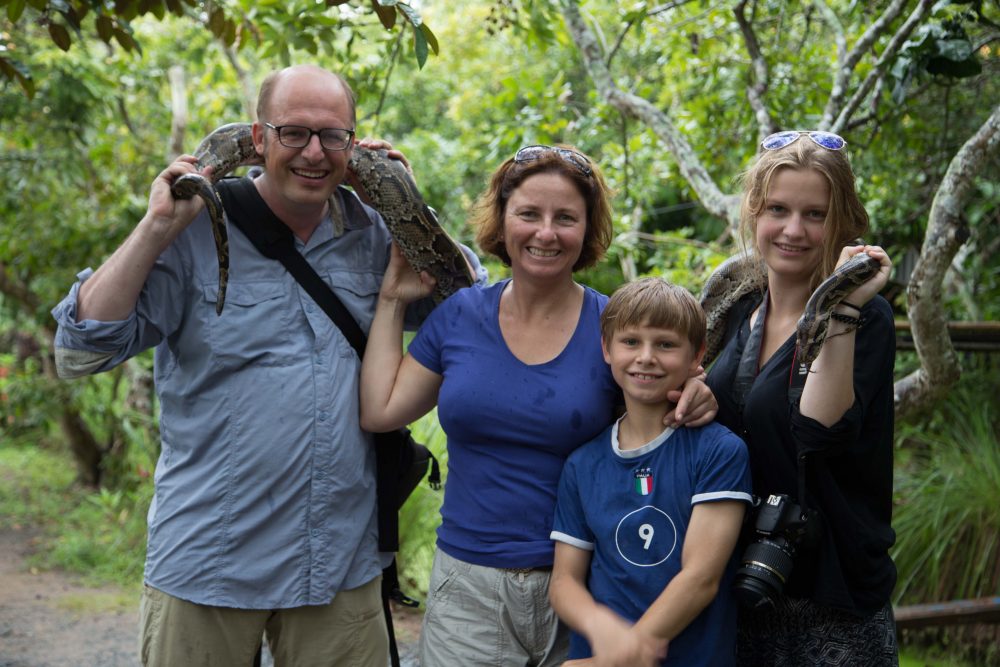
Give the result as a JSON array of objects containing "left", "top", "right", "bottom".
[{"left": 635, "top": 500, "right": 746, "bottom": 640}]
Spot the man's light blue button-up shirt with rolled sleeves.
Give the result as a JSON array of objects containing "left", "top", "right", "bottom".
[{"left": 53, "top": 189, "right": 480, "bottom": 609}]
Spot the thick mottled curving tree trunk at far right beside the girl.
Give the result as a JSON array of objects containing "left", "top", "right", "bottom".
[{"left": 895, "top": 104, "right": 1000, "bottom": 419}]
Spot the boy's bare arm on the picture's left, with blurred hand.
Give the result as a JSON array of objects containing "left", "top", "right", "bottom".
[{"left": 549, "top": 541, "right": 666, "bottom": 667}]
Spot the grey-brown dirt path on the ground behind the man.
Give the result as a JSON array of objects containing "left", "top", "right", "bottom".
[{"left": 0, "top": 528, "right": 420, "bottom": 667}]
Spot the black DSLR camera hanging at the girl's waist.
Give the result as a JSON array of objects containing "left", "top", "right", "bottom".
[{"left": 733, "top": 494, "right": 818, "bottom": 608}]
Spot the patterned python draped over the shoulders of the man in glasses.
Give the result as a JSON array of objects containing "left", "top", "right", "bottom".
[{"left": 171, "top": 123, "right": 475, "bottom": 314}]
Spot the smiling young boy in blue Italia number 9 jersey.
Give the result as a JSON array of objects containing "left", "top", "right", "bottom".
[{"left": 549, "top": 278, "right": 751, "bottom": 667}]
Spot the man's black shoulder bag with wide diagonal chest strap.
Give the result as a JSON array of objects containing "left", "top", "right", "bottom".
[{"left": 216, "top": 178, "right": 441, "bottom": 667}]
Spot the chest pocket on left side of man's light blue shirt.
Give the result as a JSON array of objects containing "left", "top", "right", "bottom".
[{"left": 202, "top": 280, "right": 296, "bottom": 366}]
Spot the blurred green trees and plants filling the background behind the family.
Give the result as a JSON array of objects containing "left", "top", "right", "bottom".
[{"left": 0, "top": 0, "right": 1000, "bottom": 664}]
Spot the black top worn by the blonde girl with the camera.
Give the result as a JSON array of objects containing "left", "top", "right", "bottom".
[{"left": 708, "top": 294, "right": 896, "bottom": 615}]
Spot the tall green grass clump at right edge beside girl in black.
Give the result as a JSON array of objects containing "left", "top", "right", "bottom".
[{"left": 892, "top": 359, "right": 1000, "bottom": 664}]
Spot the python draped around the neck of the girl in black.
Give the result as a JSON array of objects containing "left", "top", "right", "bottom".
[{"left": 701, "top": 253, "right": 880, "bottom": 366}]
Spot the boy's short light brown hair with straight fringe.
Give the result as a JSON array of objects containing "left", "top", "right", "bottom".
[{"left": 601, "top": 277, "right": 705, "bottom": 350}]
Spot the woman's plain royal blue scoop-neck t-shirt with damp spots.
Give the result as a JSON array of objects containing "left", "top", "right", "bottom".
[{"left": 409, "top": 281, "right": 621, "bottom": 568}]
